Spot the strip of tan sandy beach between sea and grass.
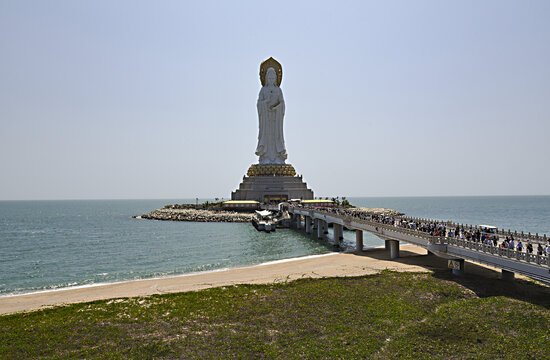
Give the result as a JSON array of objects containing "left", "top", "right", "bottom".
[{"left": 0, "top": 245, "right": 504, "bottom": 314}]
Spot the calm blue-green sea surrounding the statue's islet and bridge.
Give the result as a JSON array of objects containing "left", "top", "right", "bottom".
[{"left": 0, "top": 196, "right": 550, "bottom": 297}]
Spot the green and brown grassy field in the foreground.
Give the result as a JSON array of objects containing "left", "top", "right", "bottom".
[{"left": 0, "top": 272, "right": 550, "bottom": 359}]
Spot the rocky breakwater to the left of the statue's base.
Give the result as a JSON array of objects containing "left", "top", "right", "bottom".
[{"left": 141, "top": 205, "right": 254, "bottom": 222}]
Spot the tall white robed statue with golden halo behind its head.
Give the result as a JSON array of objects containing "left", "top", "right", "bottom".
[{"left": 256, "top": 58, "right": 287, "bottom": 165}]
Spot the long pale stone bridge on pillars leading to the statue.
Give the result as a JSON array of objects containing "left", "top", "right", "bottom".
[{"left": 288, "top": 206, "right": 550, "bottom": 284}]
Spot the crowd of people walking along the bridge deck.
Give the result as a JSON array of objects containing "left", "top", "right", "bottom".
[{"left": 298, "top": 207, "right": 550, "bottom": 256}]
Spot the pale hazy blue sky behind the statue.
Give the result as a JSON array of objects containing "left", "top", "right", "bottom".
[{"left": 0, "top": 0, "right": 550, "bottom": 200}]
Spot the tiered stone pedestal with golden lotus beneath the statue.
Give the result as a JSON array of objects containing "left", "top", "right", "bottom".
[{"left": 231, "top": 164, "right": 313, "bottom": 204}]
